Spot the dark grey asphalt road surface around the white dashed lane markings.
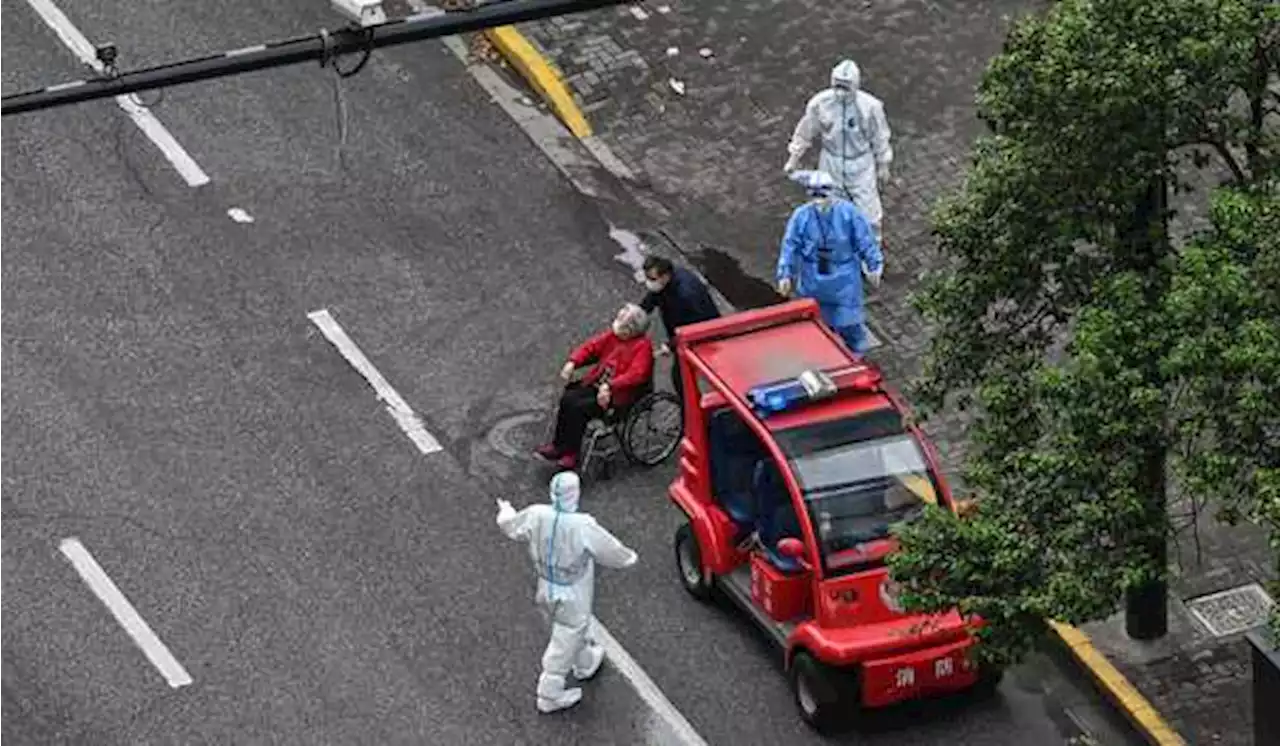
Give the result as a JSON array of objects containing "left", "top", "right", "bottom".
[{"left": 0, "top": 0, "right": 1141, "bottom": 746}]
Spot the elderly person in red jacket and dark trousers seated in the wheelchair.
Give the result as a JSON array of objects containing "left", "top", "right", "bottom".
[{"left": 538, "top": 303, "right": 653, "bottom": 468}]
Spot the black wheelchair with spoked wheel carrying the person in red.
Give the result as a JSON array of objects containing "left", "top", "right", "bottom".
[{"left": 550, "top": 365, "right": 685, "bottom": 480}]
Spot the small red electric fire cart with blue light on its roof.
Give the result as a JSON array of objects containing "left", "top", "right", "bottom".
[{"left": 668, "top": 299, "right": 1000, "bottom": 731}]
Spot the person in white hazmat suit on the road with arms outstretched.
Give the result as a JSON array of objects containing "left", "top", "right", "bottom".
[{"left": 498, "top": 471, "right": 637, "bottom": 713}]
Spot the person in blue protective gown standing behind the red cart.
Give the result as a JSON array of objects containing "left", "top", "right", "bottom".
[{"left": 776, "top": 171, "right": 884, "bottom": 354}]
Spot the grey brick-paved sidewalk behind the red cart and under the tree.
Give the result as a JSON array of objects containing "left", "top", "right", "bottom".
[{"left": 483, "top": 0, "right": 1270, "bottom": 746}]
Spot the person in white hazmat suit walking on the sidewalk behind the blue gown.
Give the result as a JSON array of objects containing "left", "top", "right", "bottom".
[{"left": 783, "top": 60, "right": 893, "bottom": 246}]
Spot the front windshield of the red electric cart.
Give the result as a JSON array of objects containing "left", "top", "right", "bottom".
[{"left": 778, "top": 409, "right": 938, "bottom": 575}]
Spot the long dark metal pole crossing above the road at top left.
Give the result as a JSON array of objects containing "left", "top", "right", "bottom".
[{"left": 0, "top": 0, "right": 628, "bottom": 116}]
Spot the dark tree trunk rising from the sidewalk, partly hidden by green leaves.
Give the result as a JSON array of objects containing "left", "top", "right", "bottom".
[{"left": 1125, "top": 174, "right": 1170, "bottom": 640}]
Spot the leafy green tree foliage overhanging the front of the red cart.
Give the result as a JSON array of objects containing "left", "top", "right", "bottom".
[{"left": 891, "top": 0, "right": 1280, "bottom": 662}]
